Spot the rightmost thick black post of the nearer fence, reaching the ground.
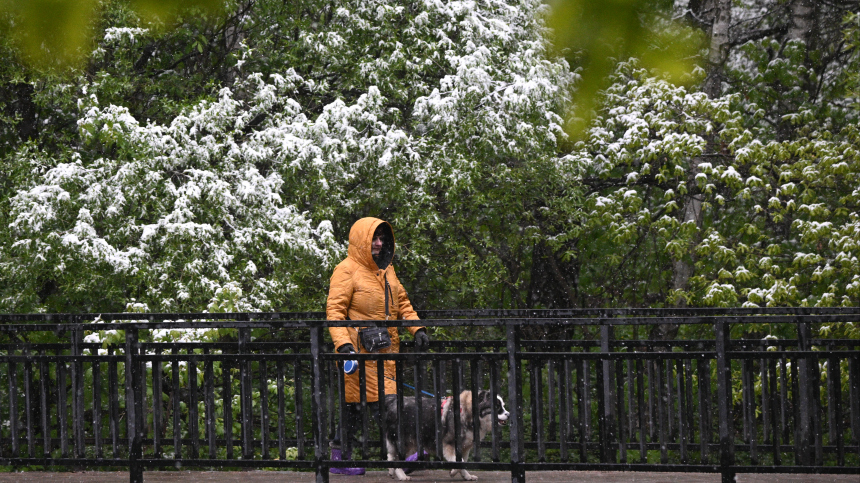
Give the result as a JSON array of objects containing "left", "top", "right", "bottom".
[{"left": 714, "top": 321, "right": 735, "bottom": 483}]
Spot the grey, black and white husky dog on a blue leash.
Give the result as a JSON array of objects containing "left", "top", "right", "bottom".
[{"left": 384, "top": 391, "right": 510, "bottom": 481}]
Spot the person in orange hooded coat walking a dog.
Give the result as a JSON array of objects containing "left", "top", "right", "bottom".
[{"left": 326, "top": 218, "right": 430, "bottom": 475}]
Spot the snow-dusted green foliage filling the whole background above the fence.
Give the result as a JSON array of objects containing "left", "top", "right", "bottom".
[{"left": 0, "top": 0, "right": 860, "bottom": 348}]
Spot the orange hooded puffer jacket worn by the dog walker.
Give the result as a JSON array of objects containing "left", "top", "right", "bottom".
[{"left": 326, "top": 218, "right": 423, "bottom": 403}]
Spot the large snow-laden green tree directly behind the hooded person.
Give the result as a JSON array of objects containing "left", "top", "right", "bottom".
[{"left": 2, "top": 1, "right": 578, "bottom": 328}]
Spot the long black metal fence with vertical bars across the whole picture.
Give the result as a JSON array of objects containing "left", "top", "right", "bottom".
[{"left": 0, "top": 308, "right": 860, "bottom": 482}]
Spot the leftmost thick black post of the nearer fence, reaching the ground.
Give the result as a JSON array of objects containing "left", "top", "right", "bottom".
[{"left": 125, "top": 327, "right": 143, "bottom": 483}]
